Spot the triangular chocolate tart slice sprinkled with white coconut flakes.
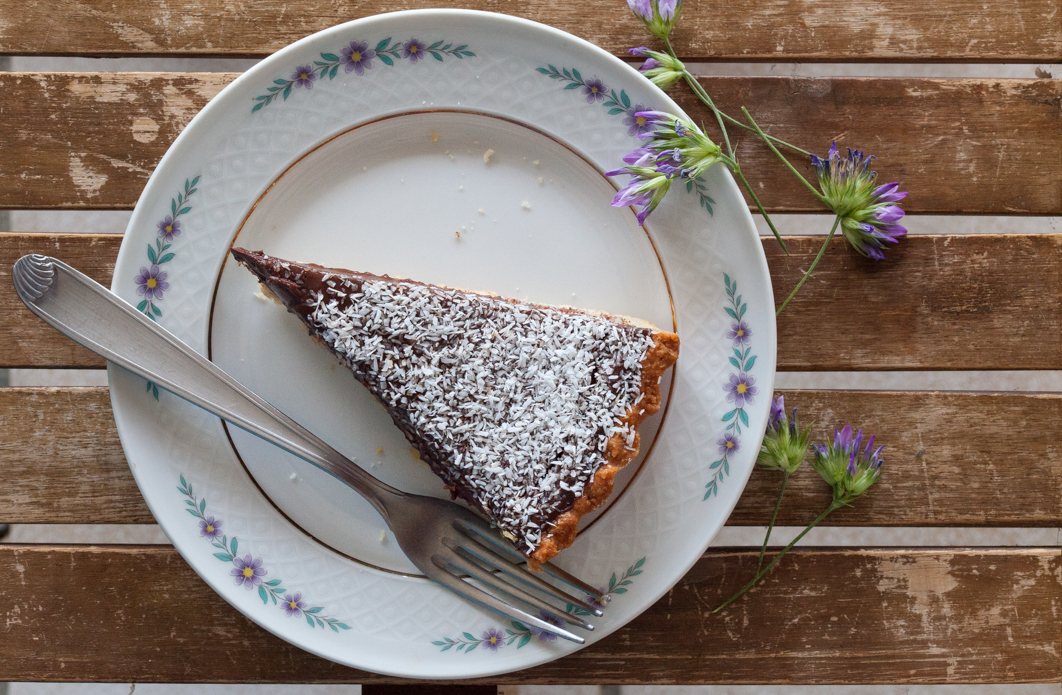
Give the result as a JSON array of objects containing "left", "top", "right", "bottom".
[{"left": 233, "top": 249, "right": 679, "bottom": 567}]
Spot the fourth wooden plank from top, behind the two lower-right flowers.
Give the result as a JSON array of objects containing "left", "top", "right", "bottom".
[{"left": 0, "top": 388, "right": 1062, "bottom": 527}]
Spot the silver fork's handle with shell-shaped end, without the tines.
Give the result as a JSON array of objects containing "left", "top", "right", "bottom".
[{"left": 12, "top": 254, "right": 405, "bottom": 524}]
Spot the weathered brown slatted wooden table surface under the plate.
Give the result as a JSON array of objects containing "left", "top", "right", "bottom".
[{"left": 0, "top": 0, "right": 1062, "bottom": 684}]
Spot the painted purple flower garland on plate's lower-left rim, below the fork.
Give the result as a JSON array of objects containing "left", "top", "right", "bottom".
[{"left": 177, "top": 475, "right": 350, "bottom": 632}]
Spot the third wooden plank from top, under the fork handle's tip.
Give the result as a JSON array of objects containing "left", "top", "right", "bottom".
[{"left": 0, "top": 234, "right": 1062, "bottom": 371}]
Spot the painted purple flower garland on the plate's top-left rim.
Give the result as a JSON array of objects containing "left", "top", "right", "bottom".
[{"left": 251, "top": 36, "right": 476, "bottom": 114}]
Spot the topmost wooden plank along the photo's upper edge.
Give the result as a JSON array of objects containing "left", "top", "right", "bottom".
[{"left": 0, "top": 0, "right": 1062, "bottom": 63}]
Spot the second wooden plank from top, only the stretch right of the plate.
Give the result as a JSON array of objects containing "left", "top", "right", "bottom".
[{"left": 670, "top": 78, "right": 1062, "bottom": 215}]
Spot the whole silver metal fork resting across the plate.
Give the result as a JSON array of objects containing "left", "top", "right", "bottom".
[{"left": 12, "top": 254, "right": 607, "bottom": 644}]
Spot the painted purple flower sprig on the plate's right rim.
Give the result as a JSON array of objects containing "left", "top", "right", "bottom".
[{"left": 704, "top": 273, "right": 758, "bottom": 499}]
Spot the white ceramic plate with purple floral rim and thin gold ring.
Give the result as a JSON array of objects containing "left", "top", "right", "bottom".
[{"left": 109, "top": 11, "right": 775, "bottom": 678}]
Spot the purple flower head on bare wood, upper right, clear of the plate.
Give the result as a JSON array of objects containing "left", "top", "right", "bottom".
[{"left": 811, "top": 142, "right": 907, "bottom": 260}]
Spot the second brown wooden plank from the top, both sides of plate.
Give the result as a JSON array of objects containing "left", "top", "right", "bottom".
[{"left": 0, "top": 72, "right": 1062, "bottom": 215}]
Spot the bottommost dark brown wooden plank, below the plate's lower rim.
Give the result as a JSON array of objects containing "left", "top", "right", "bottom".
[{"left": 0, "top": 546, "right": 1062, "bottom": 684}]
